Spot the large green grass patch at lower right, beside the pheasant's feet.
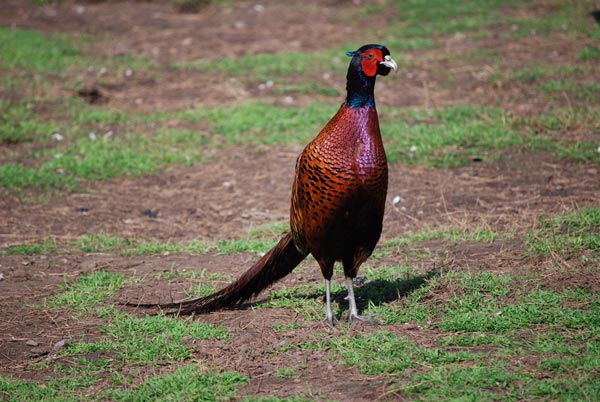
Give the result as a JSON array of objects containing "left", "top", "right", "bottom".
[{"left": 284, "top": 266, "right": 600, "bottom": 400}]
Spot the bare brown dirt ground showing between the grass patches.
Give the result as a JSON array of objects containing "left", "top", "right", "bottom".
[{"left": 0, "top": 0, "right": 600, "bottom": 401}]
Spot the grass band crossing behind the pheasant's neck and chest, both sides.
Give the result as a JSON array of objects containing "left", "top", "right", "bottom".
[{"left": 7, "top": 98, "right": 600, "bottom": 189}]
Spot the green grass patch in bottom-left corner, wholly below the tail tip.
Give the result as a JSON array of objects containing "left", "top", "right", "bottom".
[{"left": 0, "top": 307, "right": 234, "bottom": 401}]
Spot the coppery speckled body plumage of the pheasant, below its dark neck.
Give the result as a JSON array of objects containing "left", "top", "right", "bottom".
[{"left": 290, "top": 103, "right": 387, "bottom": 279}]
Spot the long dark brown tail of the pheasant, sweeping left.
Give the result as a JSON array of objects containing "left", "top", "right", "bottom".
[{"left": 126, "top": 233, "right": 306, "bottom": 315}]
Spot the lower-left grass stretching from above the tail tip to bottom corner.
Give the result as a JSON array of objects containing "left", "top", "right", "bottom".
[{"left": 0, "top": 271, "right": 239, "bottom": 401}]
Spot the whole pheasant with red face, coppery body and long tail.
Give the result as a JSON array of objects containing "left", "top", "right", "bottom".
[{"left": 137, "top": 44, "right": 398, "bottom": 325}]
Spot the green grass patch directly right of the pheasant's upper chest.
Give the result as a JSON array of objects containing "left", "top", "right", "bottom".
[{"left": 381, "top": 103, "right": 600, "bottom": 168}]
